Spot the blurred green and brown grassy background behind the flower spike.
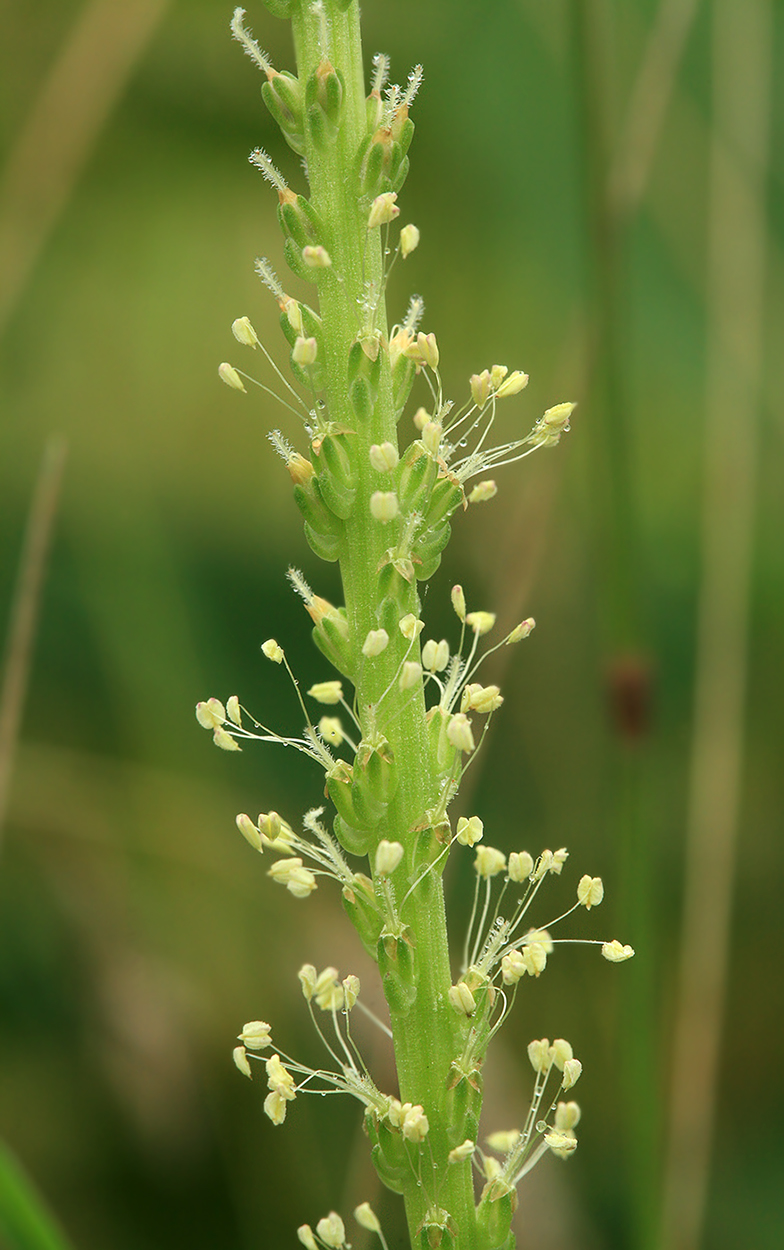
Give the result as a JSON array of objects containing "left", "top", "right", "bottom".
[{"left": 0, "top": 0, "right": 784, "bottom": 1250}]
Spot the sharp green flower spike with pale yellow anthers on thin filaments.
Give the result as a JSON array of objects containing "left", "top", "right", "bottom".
[{"left": 207, "top": 0, "right": 633, "bottom": 1250}]
